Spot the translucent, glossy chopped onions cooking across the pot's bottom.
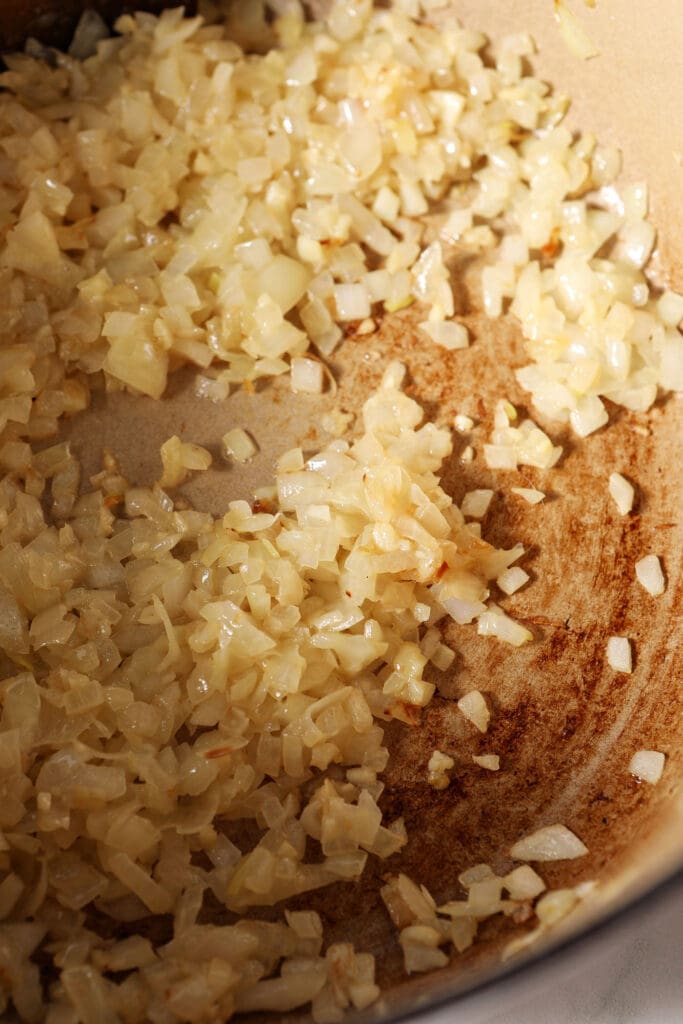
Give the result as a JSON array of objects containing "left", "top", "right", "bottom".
[{"left": 0, "top": 0, "right": 683, "bottom": 1007}]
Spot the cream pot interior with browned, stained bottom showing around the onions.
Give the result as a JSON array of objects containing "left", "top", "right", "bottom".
[{"left": 0, "top": 0, "right": 683, "bottom": 1013}]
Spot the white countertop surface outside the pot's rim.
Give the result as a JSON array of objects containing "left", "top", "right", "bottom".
[{"left": 418, "top": 885, "right": 683, "bottom": 1024}]
